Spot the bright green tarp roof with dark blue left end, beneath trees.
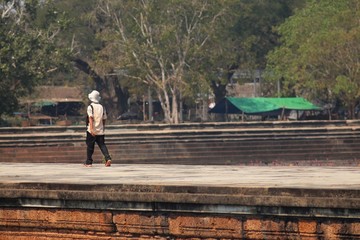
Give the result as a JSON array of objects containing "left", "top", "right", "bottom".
[{"left": 209, "top": 97, "right": 321, "bottom": 115}]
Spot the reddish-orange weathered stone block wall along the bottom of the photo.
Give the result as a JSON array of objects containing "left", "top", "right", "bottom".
[{"left": 0, "top": 208, "right": 360, "bottom": 240}]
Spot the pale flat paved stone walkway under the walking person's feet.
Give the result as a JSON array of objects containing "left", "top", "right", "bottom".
[{"left": 0, "top": 163, "right": 360, "bottom": 190}]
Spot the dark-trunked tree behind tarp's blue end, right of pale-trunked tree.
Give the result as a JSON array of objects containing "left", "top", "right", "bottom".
[{"left": 208, "top": 0, "right": 304, "bottom": 107}]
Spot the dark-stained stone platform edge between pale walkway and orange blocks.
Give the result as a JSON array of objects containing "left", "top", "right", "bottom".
[{"left": 0, "top": 183, "right": 360, "bottom": 219}]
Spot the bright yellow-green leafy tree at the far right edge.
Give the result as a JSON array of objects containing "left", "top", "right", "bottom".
[{"left": 267, "top": 0, "right": 360, "bottom": 117}]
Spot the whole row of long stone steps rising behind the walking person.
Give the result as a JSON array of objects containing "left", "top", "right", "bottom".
[{"left": 0, "top": 121, "right": 360, "bottom": 165}]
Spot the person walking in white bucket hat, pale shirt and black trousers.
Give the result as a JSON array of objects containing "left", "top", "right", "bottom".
[{"left": 84, "top": 90, "right": 111, "bottom": 167}]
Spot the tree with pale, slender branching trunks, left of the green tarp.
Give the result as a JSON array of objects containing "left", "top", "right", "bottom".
[{"left": 91, "top": 0, "right": 229, "bottom": 123}]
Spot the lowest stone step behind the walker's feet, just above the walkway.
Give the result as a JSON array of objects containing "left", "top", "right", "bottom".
[{"left": 4, "top": 152, "right": 359, "bottom": 165}]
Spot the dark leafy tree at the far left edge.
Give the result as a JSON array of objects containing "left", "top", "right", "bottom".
[{"left": 0, "top": 0, "right": 68, "bottom": 117}]
